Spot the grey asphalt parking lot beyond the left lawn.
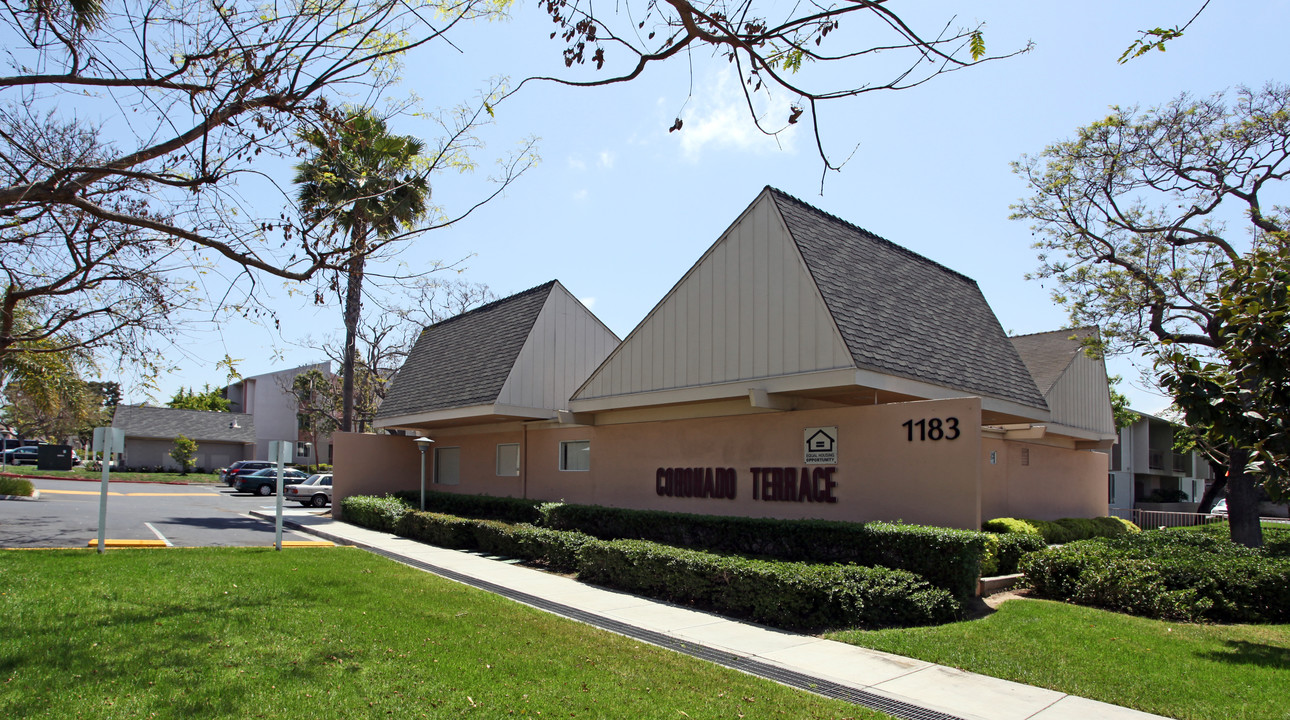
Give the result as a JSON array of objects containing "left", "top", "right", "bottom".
[{"left": 0, "top": 479, "right": 330, "bottom": 548}]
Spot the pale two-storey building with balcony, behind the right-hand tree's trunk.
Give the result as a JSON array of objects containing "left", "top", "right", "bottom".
[{"left": 1109, "top": 410, "right": 1214, "bottom": 511}]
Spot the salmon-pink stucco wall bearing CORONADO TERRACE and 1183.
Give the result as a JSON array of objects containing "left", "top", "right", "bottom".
[{"left": 333, "top": 399, "right": 995, "bottom": 528}]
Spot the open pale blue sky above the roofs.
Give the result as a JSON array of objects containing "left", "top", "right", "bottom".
[{"left": 126, "top": 0, "right": 1290, "bottom": 413}]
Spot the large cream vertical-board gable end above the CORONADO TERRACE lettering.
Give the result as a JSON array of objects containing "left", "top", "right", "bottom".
[{"left": 577, "top": 192, "right": 855, "bottom": 400}]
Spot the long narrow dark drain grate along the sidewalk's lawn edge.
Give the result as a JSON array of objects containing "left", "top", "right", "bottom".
[{"left": 292, "top": 523, "right": 962, "bottom": 720}]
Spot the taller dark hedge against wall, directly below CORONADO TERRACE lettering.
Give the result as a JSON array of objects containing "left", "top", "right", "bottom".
[{"left": 541, "top": 503, "right": 986, "bottom": 597}]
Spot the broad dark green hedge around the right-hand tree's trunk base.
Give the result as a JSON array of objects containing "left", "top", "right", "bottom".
[{"left": 1022, "top": 532, "right": 1290, "bottom": 623}]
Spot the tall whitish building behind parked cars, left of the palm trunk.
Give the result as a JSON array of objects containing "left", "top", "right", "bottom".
[{"left": 224, "top": 363, "right": 332, "bottom": 465}]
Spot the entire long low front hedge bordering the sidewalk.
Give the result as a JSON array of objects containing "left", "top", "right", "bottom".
[{"left": 341, "top": 495, "right": 960, "bottom": 631}]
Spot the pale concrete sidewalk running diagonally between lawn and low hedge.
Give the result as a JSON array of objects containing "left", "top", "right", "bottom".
[{"left": 253, "top": 511, "right": 1160, "bottom": 720}]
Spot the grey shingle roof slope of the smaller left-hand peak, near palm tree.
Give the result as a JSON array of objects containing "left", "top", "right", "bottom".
[{"left": 377, "top": 280, "right": 556, "bottom": 419}]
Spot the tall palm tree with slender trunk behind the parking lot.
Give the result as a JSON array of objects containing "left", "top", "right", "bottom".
[{"left": 295, "top": 110, "right": 430, "bottom": 432}]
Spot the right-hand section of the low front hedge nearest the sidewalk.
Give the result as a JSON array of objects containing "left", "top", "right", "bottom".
[{"left": 578, "top": 541, "right": 958, "bottom": 632}]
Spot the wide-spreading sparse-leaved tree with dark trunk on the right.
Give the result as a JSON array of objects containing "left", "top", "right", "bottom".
[{"left": 1013, "top": 84, "right": 1290, "bottom": 545}]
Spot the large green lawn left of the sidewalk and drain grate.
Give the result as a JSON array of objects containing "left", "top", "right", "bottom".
[{"left": 0, "top": 548, "right": 886, "bottom": 720}]
